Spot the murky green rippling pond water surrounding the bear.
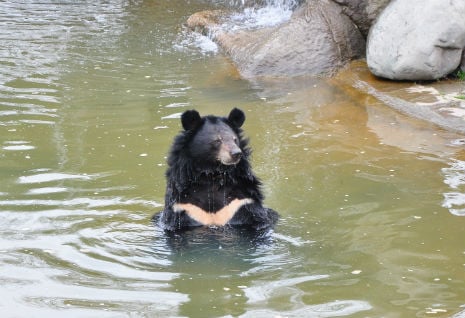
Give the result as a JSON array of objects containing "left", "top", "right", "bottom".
[{"left": 0, "top": 1, "right": 465, "bottom": 318}]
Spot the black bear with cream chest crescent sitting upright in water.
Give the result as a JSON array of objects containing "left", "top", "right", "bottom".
[{"left": 156, "top": 108, "right": 278, "bottom": 231}]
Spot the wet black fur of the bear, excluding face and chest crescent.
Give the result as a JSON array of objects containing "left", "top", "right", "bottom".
[{"left": 154, "top": 109, "right": 278, "bottom": 231}]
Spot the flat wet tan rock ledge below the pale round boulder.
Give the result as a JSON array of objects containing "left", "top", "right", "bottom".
[{"left": 332, "top": 60, "right": 465, "bottom": 135}]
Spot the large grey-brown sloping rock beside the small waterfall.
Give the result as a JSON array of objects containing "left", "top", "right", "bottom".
[{"left": 188, "top": 0, "right": 365, "bottom": 79}]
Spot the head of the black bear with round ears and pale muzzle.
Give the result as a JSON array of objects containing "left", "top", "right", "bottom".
[{"left": 181, "top": 108, "right": 245, "bottom": 166}]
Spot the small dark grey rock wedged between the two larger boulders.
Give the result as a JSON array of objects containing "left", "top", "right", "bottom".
[{"left": 333, "top": 0, "right": 391, "bottom": 38}]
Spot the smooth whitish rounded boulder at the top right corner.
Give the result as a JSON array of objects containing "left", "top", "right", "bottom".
[{"left": 367, "top": 0, "right": 465, "bottom": 80}]
